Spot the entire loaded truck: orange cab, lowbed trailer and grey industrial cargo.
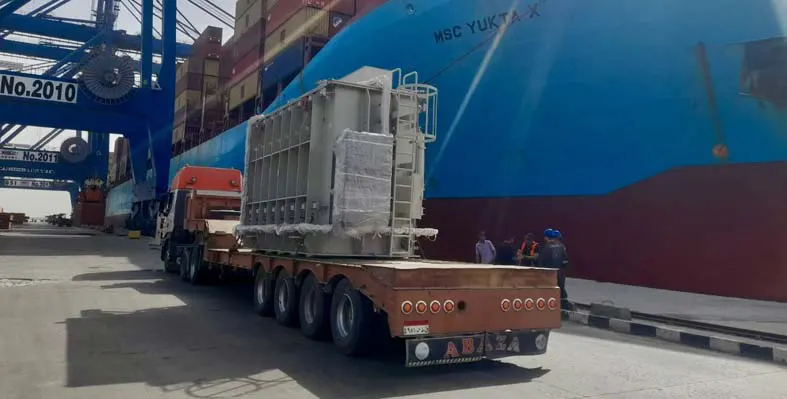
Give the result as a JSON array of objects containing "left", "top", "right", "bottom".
[{"left": 156, "top": 68, "right": 561, "bottom": 367}]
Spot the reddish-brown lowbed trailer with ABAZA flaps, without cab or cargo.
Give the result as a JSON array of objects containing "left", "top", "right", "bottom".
[{"left": 203, "top": 248, "right": 560, "bottom": 367}]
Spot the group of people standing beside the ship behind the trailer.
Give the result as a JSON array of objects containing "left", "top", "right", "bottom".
[{"left": 475, "top": 229, "right": 572, "bottom": 309}]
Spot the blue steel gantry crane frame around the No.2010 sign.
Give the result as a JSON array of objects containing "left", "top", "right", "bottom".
[{"left": 0, "top": 0, "right": 184, "bottom": 217}]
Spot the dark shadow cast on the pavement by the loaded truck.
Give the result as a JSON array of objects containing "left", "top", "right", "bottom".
[{"left": 66, "top": 271, "right": 548, "bottom": 399}]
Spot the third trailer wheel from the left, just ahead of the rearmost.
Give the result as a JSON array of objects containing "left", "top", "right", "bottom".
[{"left": 298, "top": 273, "right": 331, "bottom": 339}]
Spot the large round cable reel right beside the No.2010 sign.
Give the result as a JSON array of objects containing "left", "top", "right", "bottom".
[{"left": 80, "top": 52, "right": 134, "bottom": 104}]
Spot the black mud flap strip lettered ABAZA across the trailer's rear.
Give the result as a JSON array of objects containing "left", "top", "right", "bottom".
[{"left": 406, "top": 330, "right": 549, "bottom": 367}]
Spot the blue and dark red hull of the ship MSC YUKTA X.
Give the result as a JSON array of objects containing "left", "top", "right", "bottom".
[{"left": 110, "top": 0, "right": 787, "bottom": 301}]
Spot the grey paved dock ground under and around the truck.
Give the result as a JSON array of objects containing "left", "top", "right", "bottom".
[{"left": 0, "top": 227, "right": 787, "bottom": 399}]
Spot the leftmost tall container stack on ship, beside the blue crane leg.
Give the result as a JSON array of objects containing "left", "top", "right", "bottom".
[{"left": 172, "top": 26, "right": 226, "bottom": 155}]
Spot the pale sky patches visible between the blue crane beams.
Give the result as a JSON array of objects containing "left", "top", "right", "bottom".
[{"left": 0, "top": 0, "right": 235, "bottom": 216}]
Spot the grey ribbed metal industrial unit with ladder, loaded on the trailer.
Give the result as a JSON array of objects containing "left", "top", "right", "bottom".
[{"left": 237, "top": 68, "right": 437, "bottom": 258}]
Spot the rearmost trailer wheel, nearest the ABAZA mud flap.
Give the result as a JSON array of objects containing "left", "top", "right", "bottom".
[{"left": 331, "top": 279, "right": 374, "bottom": 355}]
